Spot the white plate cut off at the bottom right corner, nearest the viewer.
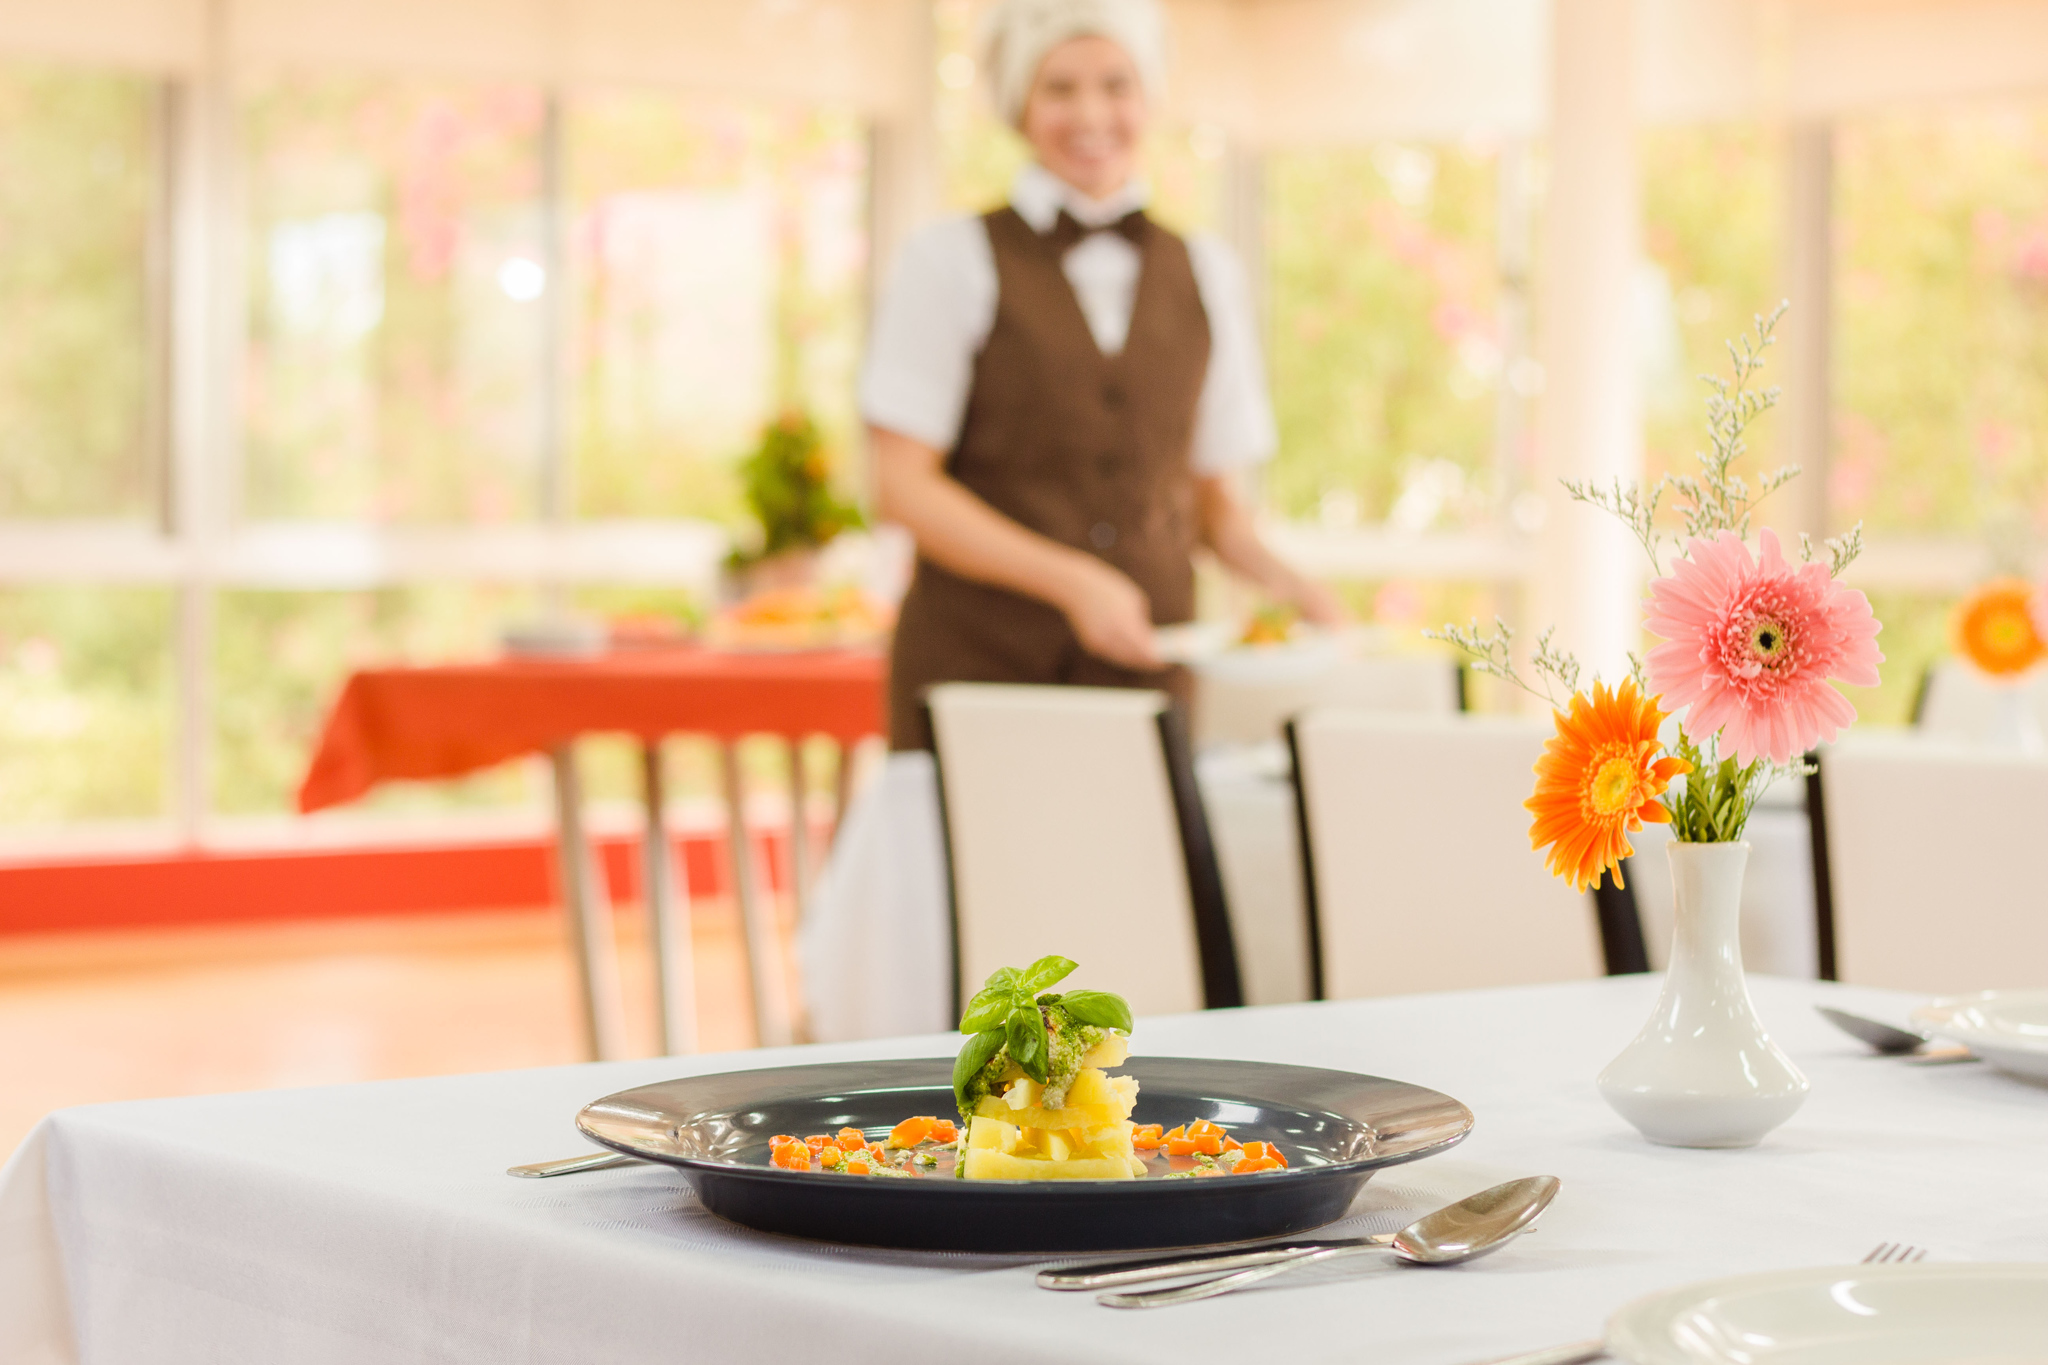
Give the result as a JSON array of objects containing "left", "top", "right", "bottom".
[{"left": 1608, "top": 1265, "right": 2048, "bottom": 1365}]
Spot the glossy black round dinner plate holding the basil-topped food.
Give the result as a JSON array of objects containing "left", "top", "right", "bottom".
[{"left": 575, "top": 1058, "right": 1473, "bottom": 1252}]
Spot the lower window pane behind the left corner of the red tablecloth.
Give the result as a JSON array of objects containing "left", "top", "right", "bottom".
[{"left": 213, "top": 585, "right": 545, "bottom": 814}]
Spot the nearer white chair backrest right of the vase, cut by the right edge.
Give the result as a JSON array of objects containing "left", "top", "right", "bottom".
[{"left": 1815, "top": 735, "right": 2048, "bottom": 993}]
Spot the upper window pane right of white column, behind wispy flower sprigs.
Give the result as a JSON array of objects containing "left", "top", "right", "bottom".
[{"left": 1638, "top": 125, "right": 1785, "bottom": 485}]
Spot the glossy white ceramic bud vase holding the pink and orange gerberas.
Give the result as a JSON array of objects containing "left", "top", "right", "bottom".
[{"left": 1599, "top": 839, "right": 1806, "bottom": 1146}]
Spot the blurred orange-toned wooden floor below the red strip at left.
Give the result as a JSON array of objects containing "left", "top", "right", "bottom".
[{"left": 0, "top": 902, "right": 786, "bottom": 1156}]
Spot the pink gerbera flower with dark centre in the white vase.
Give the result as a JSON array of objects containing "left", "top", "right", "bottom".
[{"left": 1647, "top": 530, "right": 1884, "bottom": 763}]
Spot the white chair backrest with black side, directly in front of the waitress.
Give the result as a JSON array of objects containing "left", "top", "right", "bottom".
[{"left": 926, "top": 684, "right": 1243, "bottom": 1015}]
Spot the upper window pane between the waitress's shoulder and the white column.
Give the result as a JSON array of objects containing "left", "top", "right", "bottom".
[{"left": 1266, "top": 143, "right": 1505, "bottom": 532}]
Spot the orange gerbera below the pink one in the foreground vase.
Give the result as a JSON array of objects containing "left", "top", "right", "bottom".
[{"left": 1522, "top": 677, "right": 1692, "bottom": 890}]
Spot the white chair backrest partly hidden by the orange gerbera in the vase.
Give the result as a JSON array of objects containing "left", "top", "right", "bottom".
[{"left": 1288, "top": 710, "right": 1604, "bottom": 1001}]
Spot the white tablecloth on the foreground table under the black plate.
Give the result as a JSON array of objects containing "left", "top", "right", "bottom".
[{"left": 0, "top": 978, "right": 2048, "bottom": 1365}]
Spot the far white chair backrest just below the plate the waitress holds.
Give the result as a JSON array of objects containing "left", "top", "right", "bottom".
[{"left": 1194, "top": 651, "right": 1464, "bottom": 749}]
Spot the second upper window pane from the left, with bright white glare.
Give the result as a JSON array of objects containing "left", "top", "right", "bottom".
[{"left": 242, "top": 76, "right": 549, "bottom": 522}]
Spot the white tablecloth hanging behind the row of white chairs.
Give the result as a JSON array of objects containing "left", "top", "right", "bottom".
[{"left": 799, "top": 745, "right": 1817, "bottom": 1042}]
